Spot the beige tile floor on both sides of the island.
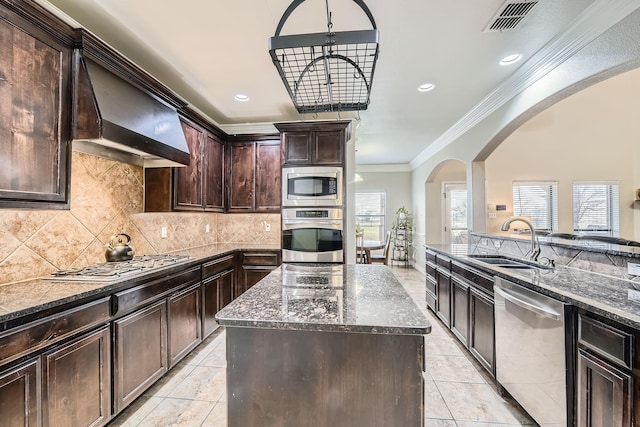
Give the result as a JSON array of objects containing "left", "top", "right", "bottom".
[{"left": 109, "top": 267, "right": 535, "bottom": 427}]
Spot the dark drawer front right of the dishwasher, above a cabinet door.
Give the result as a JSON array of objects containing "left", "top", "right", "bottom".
[{"left": 578, "top": 314, "right": 633, "bottom": 369}]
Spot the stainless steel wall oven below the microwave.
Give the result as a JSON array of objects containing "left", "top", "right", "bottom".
[{"left": 282, "top": 208, "right": 344, "bottom": 263}]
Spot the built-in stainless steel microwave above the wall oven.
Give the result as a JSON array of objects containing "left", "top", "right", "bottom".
[{"left": 282, "top": 166, "right": 343, "bottom": 206}]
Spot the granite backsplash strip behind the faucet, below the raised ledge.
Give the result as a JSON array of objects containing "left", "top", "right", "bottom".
[{"left": 468, "top": 232, "right": 640, "bottom": 281}]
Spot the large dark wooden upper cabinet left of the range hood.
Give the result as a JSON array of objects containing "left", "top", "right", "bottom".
[{"left": 0, "top": 0, "right": 73, "bottom": 209}]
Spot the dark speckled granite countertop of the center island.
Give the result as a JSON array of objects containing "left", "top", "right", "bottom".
[{"left": 216, "top": 264, "right": 431, "bottom": 335}]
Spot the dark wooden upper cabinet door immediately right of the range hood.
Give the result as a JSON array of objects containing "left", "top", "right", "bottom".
[{"left": 174, "top": 119, "right": 204, "bottom": 210}]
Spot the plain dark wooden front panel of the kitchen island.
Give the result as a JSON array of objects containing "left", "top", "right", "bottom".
[{"left": 226, "top": 327, "right": 424, "bottom": 427}]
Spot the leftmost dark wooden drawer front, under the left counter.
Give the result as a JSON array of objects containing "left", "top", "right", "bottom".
[{"left": 0, "top": 297, "right": 110, "bottom": 364}]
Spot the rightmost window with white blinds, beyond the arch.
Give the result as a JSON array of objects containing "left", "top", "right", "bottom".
[{"left": 573, "top": 182, "right": 620, "bottom": 237}]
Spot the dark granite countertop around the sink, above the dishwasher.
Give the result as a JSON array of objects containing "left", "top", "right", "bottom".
[{"left": 425, "top": 245, "right": 640, "bottom": 329}]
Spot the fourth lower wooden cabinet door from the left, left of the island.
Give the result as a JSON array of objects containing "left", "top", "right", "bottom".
[{"left": 167, "top": 283, "right": 202, "bottom": 368}]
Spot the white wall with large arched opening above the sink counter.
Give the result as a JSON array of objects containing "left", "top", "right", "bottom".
[{"left": 412, "top": 10, "right": 640, "bottom": 267}]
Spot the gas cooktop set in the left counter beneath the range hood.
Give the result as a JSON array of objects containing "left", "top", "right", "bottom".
[{"left": 43, "top": 254, "right": 192, "bottom": 282}]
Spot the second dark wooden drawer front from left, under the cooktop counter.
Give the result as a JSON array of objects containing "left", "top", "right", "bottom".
[{"left": 113, "top": 266, "right": 200, "bottom": 315}]
